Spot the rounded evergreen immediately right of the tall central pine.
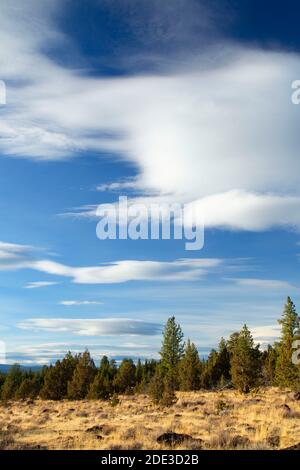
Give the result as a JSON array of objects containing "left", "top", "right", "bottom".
[{"left": 179, "top": 339, "right": 201, "bottom": 391}]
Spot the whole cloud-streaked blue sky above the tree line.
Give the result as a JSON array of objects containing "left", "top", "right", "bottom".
[{"left": 0, "top": 0, "right": 300, "bottom": 364}]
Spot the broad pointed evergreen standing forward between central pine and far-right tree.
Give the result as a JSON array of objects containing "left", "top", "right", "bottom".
[{"left": 231, "top": 325, "right": 261, "bottom": 393}]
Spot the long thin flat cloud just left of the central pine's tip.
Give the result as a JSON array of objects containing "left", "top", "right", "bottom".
[{"left": 17, "top": 318, "right": 162, "bottom": 336}]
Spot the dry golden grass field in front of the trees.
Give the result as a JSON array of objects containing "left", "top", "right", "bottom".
[{"left": 0, "top": 388, "right": 300, "bottom": 450}]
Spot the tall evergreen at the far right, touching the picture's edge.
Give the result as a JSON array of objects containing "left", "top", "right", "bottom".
[{"left": 275, "top": 297, "right": 300, "bottom": 389}]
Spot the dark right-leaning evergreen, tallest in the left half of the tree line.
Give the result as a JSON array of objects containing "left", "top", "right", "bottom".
[{"left": 68, "top": 350, "right": 97, "bottom": 400}]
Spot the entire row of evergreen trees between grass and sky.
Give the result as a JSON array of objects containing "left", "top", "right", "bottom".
[{"left": 0, "top": 297, "right": 300, "bottom": 406}]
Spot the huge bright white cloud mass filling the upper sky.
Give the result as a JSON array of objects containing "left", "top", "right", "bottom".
[{"left": 0, "top": 0, "right": 300, "bottom": 230}]
